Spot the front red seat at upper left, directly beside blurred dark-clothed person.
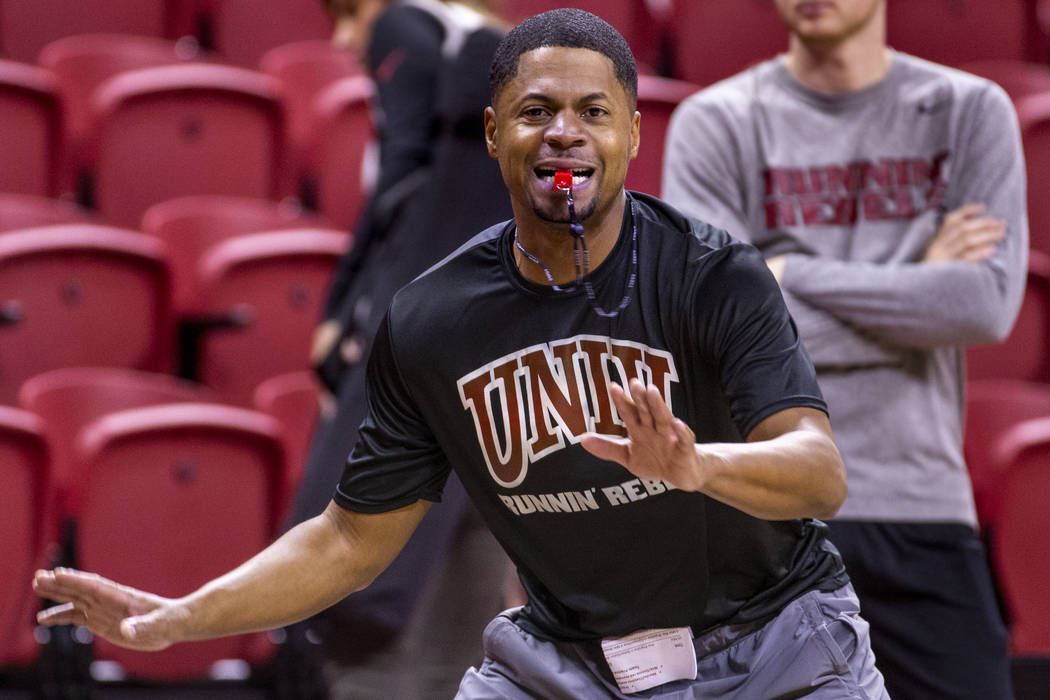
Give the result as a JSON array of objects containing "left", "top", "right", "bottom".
[{"left": 305, "top": 76, "right": 374, "bottom": 231}]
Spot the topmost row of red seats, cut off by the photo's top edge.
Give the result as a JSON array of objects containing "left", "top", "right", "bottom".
[{"left": 0, "top": 0, "right": 1050, "bottom": 85}]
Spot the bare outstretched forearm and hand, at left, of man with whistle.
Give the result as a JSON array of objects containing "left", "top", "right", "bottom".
[{"left": 33, "top": 501, "right": 429, "bottom": 651}]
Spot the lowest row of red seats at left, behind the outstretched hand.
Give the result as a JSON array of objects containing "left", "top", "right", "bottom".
[{"left": 0, "top": 367, "right": 317, "bottom": 680}]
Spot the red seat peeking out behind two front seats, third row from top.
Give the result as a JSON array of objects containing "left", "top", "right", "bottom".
[{"left": 142, "top": 195, "right": 327, "bottom": 314}]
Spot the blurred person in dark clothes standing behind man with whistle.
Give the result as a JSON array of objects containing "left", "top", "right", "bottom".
[{"left": 290, "top": 0, "right": 511, "bottom": 700}]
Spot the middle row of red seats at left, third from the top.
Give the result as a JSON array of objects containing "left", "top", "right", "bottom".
[{"left": 0, "top": 195, "right": 350, "bottom": 404}]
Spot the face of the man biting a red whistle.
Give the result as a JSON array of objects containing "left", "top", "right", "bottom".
[{"left": 485, "top": 46, "right": 639, "bottom": 222}]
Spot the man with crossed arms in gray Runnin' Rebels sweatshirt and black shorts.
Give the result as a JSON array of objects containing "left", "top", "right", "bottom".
[{"left": 663, "top": 0, "right": 1028, "bottom": 700}]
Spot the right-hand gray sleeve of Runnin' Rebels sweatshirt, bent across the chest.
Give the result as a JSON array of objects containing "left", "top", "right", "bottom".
[{"left": 781, "top": 83, "right": 1028, "bottom": 348}]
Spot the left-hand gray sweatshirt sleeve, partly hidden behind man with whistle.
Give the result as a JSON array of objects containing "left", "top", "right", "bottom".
[{"left": 662, "top": 92, "right": 901, "bottom": 369}]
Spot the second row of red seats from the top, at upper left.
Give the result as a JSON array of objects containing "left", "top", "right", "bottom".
[{"left": 0, "top": 35, "right": 372, "bottom": 228}]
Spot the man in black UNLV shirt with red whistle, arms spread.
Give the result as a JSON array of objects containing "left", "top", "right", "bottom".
[{"left": 36, "top": 9, "right": 886, "bottom": 699}]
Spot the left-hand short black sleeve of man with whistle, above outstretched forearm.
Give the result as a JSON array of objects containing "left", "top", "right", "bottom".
[{"left": 334, "top": 318, "right": 449, "bottom": 513}]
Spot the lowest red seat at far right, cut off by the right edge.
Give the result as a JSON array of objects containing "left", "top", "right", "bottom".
[{"left": 991, "top": 418, "right": 1050, "bottom": 656}]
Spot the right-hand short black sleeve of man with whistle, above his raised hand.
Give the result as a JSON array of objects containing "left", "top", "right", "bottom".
[{"left": 695, "top": 242, "right": 827, "bottom": 436}]
